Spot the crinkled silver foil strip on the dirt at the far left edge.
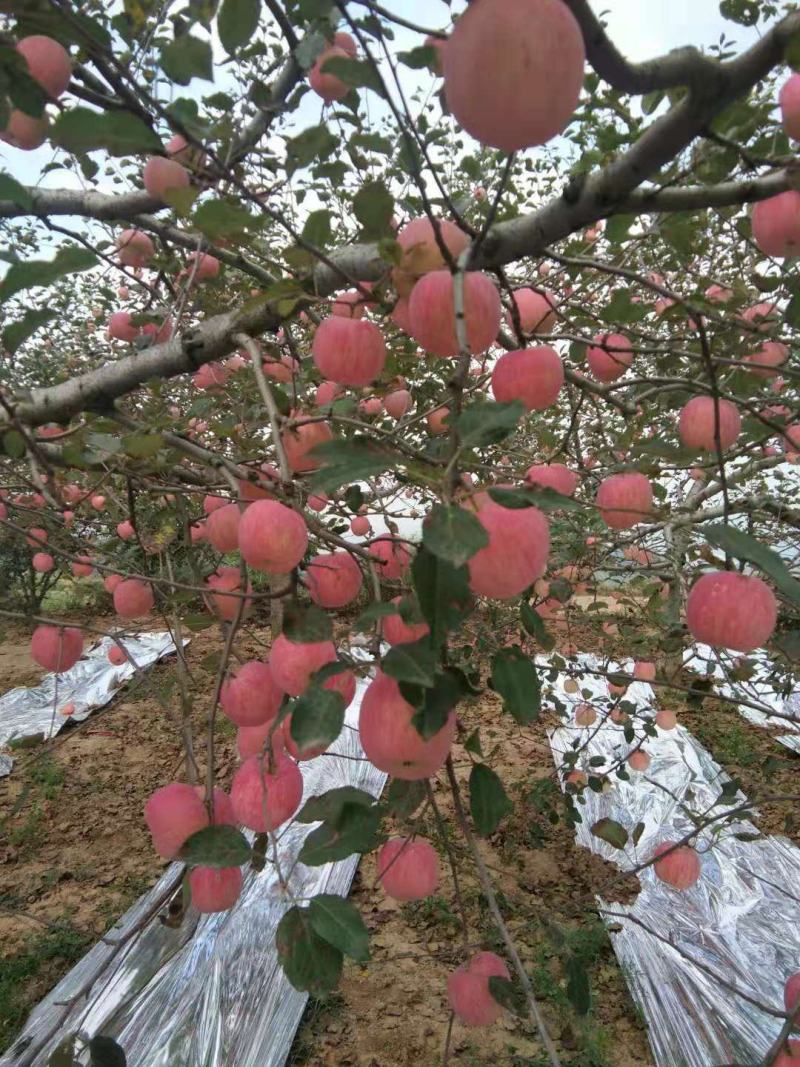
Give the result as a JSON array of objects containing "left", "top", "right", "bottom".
[{"left": 0, "top": 631, "right": 181, "bottom": 776}]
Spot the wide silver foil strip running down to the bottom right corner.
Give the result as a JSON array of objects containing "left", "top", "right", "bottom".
[{"left": 540, "top": 655, "right": 800, "bottom": 1067}]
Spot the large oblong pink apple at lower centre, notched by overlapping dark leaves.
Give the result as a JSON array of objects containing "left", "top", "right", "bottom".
[{"left": 358, "top": 671, "right": 455, "bottom": 781}]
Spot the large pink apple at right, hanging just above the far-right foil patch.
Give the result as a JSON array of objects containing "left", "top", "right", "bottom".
[{"left": 686, "top": 571, "right": 778, "bottom": 652}]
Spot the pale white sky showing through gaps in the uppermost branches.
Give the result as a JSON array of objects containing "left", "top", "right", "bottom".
[{"left": 0, "top": 0, "right": 772, "bottom": 203}]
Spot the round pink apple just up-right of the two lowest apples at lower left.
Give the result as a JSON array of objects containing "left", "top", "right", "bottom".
[{"left": 230, "top": 753, "right": 303, "bottom": 833}]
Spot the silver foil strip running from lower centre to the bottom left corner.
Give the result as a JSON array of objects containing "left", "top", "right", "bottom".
[{"left": 0, "top": 661, "right": 386, "bottom": 1067}]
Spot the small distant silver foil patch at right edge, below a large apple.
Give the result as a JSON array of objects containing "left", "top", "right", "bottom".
[{"left": 684, "top": 644, "right": 800, "bottom": 752}]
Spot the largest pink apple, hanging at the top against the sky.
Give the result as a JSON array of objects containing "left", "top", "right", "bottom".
[{"left": 443, "top": 0, "right": 586, "bottom": 152}]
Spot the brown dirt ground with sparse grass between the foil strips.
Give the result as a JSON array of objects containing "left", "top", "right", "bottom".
[{"left": 0, "top": 588, "right": 798, "bottom": 1067}]
